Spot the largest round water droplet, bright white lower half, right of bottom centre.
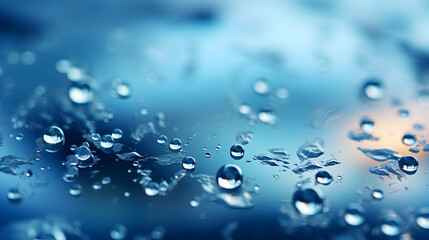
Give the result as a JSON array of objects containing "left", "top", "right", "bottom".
[{"left": 292, "top": 185, "right": 324, "bottom": 216}]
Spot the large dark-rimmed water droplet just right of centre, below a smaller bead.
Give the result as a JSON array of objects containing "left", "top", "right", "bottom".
[{"left": 216, "top": 164, "right": 243, "bottom": 190}]
